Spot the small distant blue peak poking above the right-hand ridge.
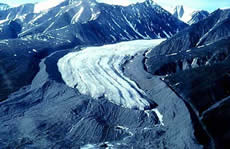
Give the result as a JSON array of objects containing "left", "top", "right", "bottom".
[{"left": 188, "top": 10, "right": 209, "bottom": 25}]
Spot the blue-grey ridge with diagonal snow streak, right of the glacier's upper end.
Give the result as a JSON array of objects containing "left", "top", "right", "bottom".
[{"left": 147, "top": 9, "right": 230, "bottom": 59}]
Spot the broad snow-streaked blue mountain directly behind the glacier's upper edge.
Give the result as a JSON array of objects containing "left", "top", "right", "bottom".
[{"left": 0, "top": 0, "right": 187, "bottom": 42}]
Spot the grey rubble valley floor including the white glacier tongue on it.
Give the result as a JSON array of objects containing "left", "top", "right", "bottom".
[{"left": 0, "top": 40, "right": 202, "bottom": 149}]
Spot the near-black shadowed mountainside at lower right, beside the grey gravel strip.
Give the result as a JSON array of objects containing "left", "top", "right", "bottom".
[{"left": 162, "top": 37, "right": 230, "bottom": 149}]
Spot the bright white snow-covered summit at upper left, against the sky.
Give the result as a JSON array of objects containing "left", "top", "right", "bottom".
[{"left": 34, "top": 0, "right": 65, "bottom": 13}]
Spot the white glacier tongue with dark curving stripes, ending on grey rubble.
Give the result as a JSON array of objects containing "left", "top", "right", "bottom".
[{"left": 58, "top": 39, "right": 163, "bottom": 110}]
